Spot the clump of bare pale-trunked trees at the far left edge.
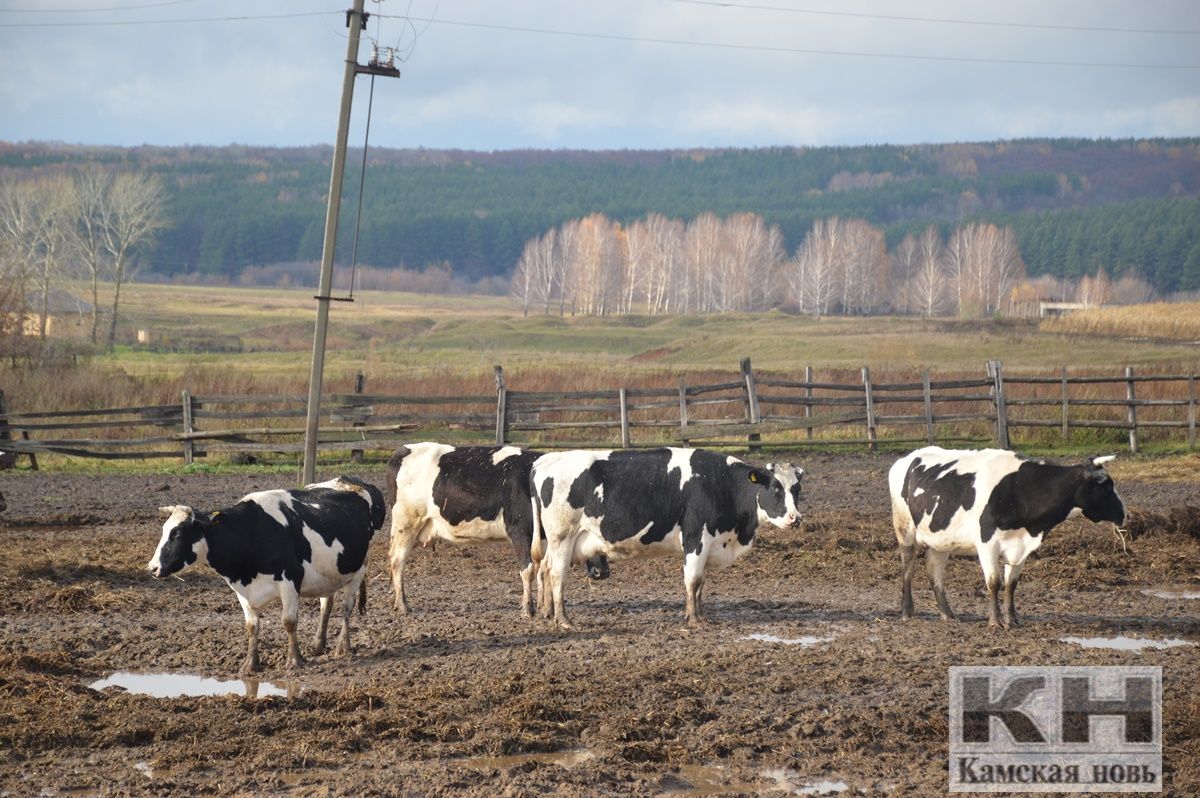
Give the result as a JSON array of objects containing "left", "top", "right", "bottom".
[{"left": 0, "top": 164, "right": 167, "bottom": 349}]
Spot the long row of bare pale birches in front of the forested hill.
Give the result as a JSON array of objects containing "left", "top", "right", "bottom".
[{"left": 510, "top": 214, "right": 1151, "bottom": 318}]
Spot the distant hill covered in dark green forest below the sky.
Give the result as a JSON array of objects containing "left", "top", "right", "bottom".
[{"left": 0, "top": 138, "right": 1200, "bottom": 293}]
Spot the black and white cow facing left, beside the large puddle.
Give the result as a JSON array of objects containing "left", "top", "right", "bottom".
[{"left": 148, "top": 476, "right": 386, "bottom": 671}]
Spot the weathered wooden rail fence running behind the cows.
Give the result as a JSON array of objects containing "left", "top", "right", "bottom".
[{"left": 0, "top": 359, "right": 1196, "bottom": 468}]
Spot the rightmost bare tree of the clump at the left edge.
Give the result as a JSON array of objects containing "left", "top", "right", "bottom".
[{"left": 103, "top": 172, "right": 167, "bottom": 350}]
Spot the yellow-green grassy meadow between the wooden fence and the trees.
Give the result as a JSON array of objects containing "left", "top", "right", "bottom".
[{"left": 101, "top": 286, "right": 1200, "bottom": 383}]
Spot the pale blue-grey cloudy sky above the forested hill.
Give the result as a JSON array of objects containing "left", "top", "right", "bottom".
[{"left": 0, "top": 0, "right": 1200, "bottom": 150}]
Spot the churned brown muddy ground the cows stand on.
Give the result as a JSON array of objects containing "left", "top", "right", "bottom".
[{"left": 0, "top": 455, "right": 1200, "bottom": 796}]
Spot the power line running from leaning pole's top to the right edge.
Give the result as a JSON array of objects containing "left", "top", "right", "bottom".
[{"left": 380, "top": 14, "right": 1200, "bottom": 70}]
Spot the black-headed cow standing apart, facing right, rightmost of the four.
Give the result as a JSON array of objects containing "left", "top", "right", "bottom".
[{"left": 888, "top": 446, "right": 1126, "bottom": 626}]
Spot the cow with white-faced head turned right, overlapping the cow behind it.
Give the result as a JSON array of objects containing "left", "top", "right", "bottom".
[{"left": 530, "top": 449, "right": 803, "bottom": 629}]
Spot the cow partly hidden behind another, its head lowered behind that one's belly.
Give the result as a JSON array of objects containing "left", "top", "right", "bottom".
[{"left": 386, "top": 443, "right": 608, "bottom": 617}]
